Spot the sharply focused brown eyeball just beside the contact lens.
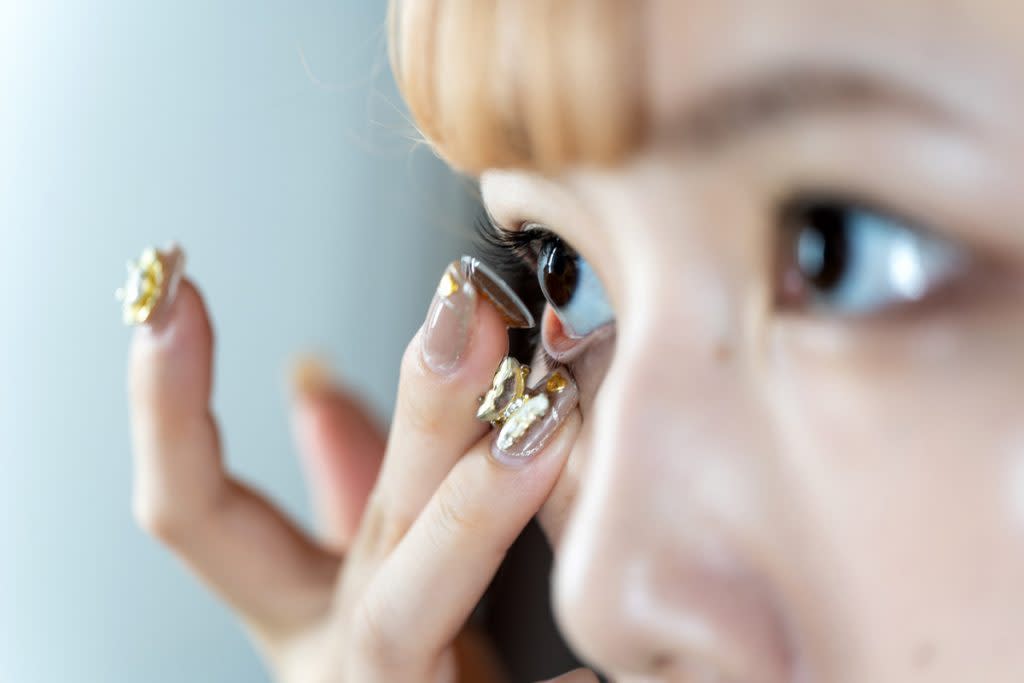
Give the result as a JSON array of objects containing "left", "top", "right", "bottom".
[{"left": 537, "top": 237, "right": 614, "bottom": 338}]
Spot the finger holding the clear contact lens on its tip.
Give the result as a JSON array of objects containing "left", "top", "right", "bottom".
[{"left": 368, "top": 257, "right": 532, "bottom": 551}]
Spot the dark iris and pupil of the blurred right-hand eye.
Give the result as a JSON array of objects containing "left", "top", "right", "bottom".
[{"left": 797, "top": 201, "right": 848, "bottom": 291}]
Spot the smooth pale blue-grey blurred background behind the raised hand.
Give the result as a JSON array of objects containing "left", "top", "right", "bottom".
[{"left": 0, "top": 0, "right": 472, "bottom": 683}]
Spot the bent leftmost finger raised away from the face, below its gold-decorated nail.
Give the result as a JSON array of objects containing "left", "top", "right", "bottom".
[{"left": 130, "top": 270, "right": 338, "bottom": 629}]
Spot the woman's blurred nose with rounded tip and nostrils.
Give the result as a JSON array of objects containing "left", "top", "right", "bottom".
[{"left": 554, "top": 321, "right": 794, "bottom": 683}]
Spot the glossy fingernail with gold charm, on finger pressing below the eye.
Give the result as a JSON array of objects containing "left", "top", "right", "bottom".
[{"left": 490, "top": 368, "right": 580, "bottom": 467}]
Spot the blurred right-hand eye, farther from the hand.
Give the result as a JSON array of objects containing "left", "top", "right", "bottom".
[{"left": 777, "top": 201, "right": 966, "bottom": 315}]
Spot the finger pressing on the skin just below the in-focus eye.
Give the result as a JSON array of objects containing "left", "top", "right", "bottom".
[{"left": 356, "top": 371, "right": 580, "bottom": 680}]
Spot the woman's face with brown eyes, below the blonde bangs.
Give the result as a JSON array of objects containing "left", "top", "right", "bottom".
[{"left": 482, "top": 0, "right": 1024, "bottom": 683}]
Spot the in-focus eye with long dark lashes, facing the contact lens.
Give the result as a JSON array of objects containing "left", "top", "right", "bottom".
[{"left": 473, "top": 223, "right": 614, "bottom": 339}]
